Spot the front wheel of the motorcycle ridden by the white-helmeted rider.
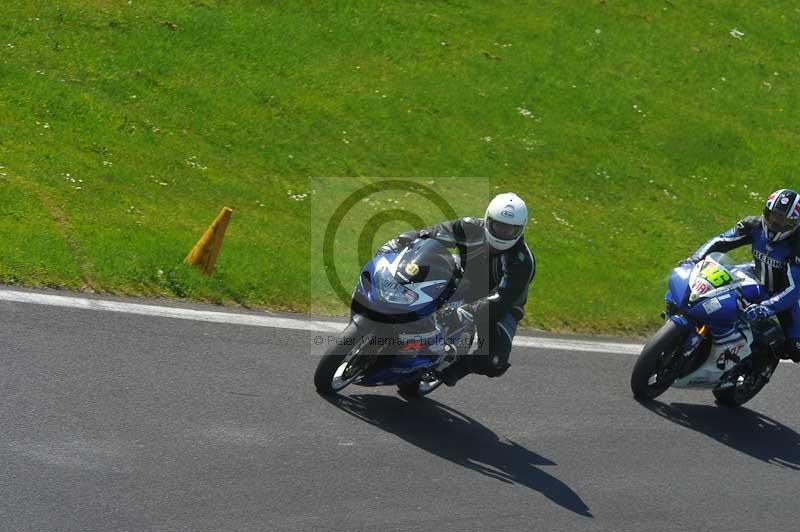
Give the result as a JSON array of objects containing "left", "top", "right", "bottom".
[{"left": 314, "top": 323, "right": 370, "bottom": 395}]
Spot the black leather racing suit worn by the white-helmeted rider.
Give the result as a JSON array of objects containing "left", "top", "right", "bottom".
[{"left": 386, "top": 217, "right": 536, "bottom": 377}]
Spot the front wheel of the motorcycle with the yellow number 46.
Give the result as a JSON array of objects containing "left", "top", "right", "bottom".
[{"left": 631, "top": 320, "right": 687, "bottom": 400}]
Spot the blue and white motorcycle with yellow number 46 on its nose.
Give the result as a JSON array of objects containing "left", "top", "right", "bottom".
[{"left": 631, "top": 253, "right": 784, "bottom": 406}]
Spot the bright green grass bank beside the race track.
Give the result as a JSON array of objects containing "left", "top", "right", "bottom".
[{"left": 0, "top": 0, "right": 800, "bottom": 333}]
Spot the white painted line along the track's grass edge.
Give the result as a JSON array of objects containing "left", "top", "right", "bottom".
[{"left": 0, "top": 290, "right": 642, "bottom": 355}]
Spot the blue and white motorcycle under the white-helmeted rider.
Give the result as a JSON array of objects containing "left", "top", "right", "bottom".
[{"left": 314, "top": 239, "right": 475, "bottom": 398}]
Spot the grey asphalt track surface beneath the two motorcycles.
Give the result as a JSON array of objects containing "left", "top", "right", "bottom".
[{"left": 0, "top": 294, "right": 800, "bottom": 532}]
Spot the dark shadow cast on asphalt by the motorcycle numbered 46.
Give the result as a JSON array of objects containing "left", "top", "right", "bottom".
[{"left": 641, "top": 401, "right": 800, "bottom": 471}]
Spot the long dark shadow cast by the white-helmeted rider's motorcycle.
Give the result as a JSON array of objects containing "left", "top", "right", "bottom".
[{"left": 328, "top": 394, "right": 593, "bottom": 518}]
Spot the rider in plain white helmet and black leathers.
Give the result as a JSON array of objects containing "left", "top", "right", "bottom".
[{"left": 381, "top": 192, "right": 536, "bottom": 386}]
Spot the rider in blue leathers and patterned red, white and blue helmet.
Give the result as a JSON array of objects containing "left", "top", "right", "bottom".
[{"left": 686, "top": 189, "right": 800, "bottom": 362}]
